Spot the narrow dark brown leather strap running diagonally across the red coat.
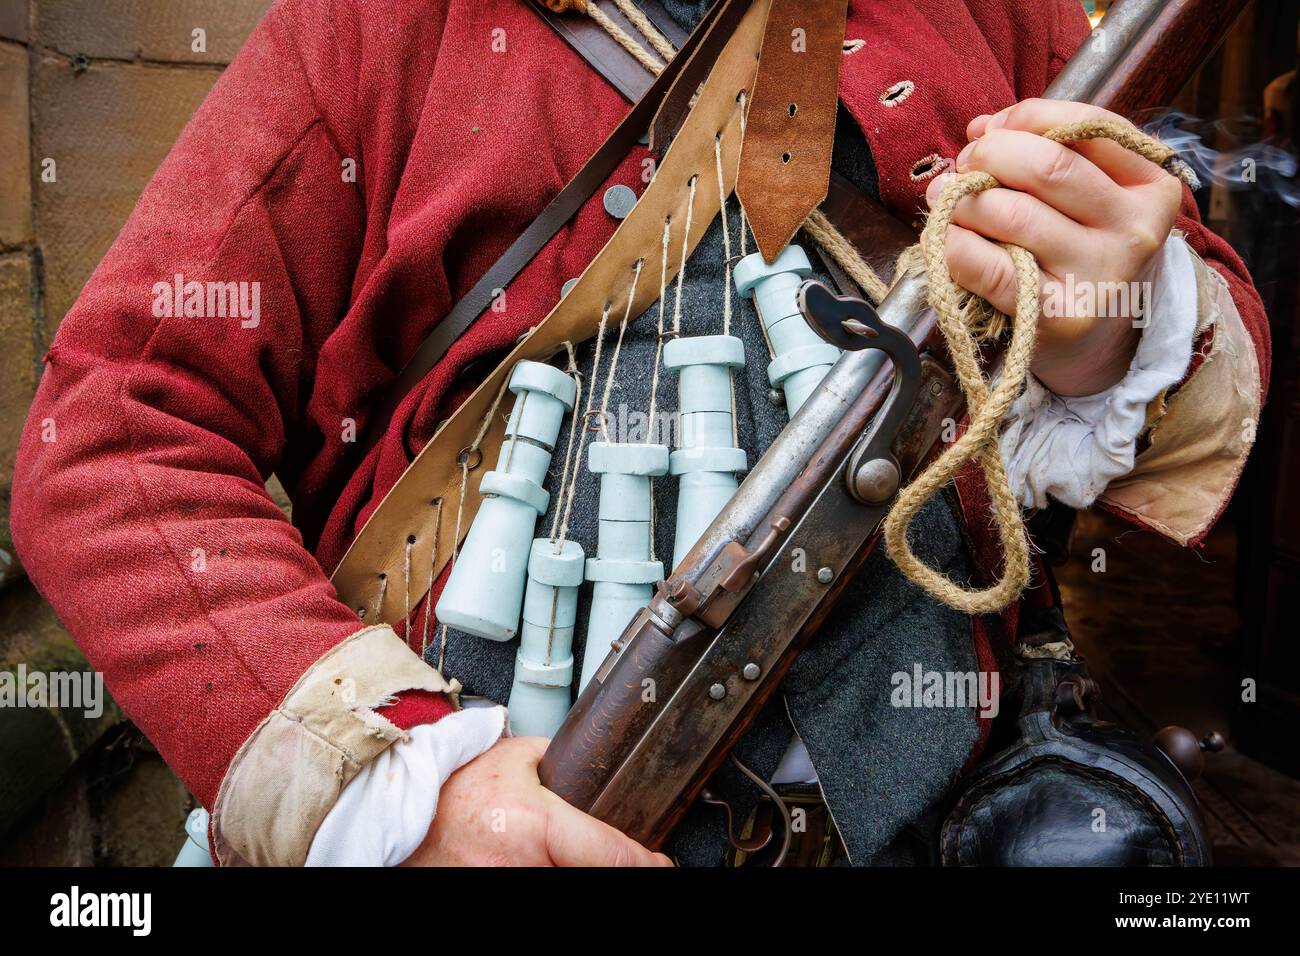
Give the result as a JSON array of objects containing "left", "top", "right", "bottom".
[{"left": 358, "top": 0, "right": 750, "bottom": 455}]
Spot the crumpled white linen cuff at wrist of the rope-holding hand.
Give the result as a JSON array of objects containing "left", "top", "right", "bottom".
[{"left": 1001, "top": 235, "right": 1197, "bottom": 509}]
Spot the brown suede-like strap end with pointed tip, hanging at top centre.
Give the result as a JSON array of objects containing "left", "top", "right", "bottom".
[{"left": 736, "top": 0, "right": 849, "bottom": 261}]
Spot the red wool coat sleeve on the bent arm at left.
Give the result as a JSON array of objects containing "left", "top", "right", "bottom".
[{"left": 13, "top": 0, "right": 447, "bottom": 822}]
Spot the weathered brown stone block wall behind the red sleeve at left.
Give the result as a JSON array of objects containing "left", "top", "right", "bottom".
[{"left": 0, "top": 0, "right": 270, "bottom": 864}]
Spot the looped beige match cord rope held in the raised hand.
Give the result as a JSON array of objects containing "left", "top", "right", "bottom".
[{"left": 884, "top": 120, "right": 1191, "bottom": 614}]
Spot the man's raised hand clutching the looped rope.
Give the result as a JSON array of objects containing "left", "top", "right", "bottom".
[{"left": 926, "top": 100, "right": 1183, "bottom": 395}]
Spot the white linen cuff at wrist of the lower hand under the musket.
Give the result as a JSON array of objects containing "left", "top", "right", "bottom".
[{"left": 307, "top": 706, "right": 506, "bottom": 866}]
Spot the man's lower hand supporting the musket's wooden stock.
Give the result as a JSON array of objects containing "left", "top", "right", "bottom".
[{"left": 403, "top": 737, "right": 672, "bottom": 866}]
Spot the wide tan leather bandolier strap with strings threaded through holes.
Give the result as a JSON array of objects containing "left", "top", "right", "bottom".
[{"left": 332, "top": 0, "right": 767, "bottom": 623}]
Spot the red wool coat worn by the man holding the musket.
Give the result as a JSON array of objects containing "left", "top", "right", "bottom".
[{"left": 13, "top": 0, "right": 1268, "bottom": 858}]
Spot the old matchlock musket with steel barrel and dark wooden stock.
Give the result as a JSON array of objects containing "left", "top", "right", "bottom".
[{"left": 540, "top": 0, "right": 1247, "bottom": 848}]
